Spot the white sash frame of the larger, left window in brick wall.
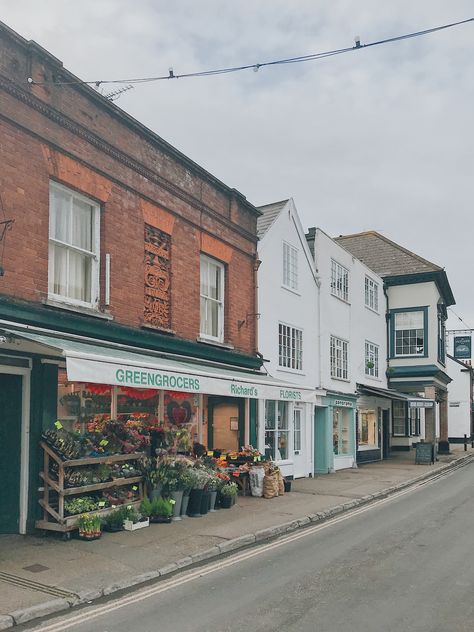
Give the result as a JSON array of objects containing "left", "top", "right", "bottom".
[{"left": 48, "top": 181, "right": 100, "bottom": 310}]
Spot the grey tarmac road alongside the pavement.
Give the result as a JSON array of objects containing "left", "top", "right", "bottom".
[{"left": 24, "top": 464, "right": 474, "bottom": 632}]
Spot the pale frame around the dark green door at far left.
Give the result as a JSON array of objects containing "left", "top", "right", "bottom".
[{"left": 0, "top": 356, "right": 31, "bottom": 535}]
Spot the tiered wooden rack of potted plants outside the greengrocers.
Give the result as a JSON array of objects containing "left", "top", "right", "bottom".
[{"left": 36, "top": 426, "right": 147, "bottom": 537}]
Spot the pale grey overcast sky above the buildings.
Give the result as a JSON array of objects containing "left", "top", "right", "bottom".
[{"left": 0, "top": 0, "right": 474, "bottom": 328}]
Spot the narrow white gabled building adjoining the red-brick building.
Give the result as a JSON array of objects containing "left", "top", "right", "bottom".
[{"left": 258, "top": 199, "right": 321, "bottom": 478}]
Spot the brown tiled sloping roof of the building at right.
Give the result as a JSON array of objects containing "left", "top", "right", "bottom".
[{"left": 335, "top": 231, "right": 443, "bottom": 277}]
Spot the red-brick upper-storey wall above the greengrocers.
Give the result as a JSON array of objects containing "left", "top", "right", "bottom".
[{"left": 0, "top": 25, "right": 256, "bottom": 353}]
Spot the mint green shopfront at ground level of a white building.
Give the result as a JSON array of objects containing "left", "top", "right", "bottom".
[{"left": 314, "top": 391, "right": 357, "bottom": 474}]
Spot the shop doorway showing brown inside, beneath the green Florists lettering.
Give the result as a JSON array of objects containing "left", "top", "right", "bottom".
[{"left": 207, "top": 397, "right": 245, "bottom": 451}]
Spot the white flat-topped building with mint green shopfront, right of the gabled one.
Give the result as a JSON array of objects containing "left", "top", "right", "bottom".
[{"left": 306, "top": 228, "right": 407, "bottom": 472}]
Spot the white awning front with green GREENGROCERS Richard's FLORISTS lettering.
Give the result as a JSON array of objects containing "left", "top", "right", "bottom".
[{"left": 66, "top": 356, "right": 318, "bottom": 407}]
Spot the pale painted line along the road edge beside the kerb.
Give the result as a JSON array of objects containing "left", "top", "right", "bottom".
[{"left": 32, "top": 464, "right": 470, "bottom": 632}]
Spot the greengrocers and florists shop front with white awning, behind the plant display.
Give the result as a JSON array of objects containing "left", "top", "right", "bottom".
[{"left": 0, "top": 330, "right": 314, "bottom": 533}]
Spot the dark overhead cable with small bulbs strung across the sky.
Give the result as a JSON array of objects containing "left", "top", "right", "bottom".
[{"left": 28, "top": 18, "right": 474, "bottom": 87}]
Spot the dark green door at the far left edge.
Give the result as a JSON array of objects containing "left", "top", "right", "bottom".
[{"left": 0, "top": 373, "right": 23, "bottom": 533}]
